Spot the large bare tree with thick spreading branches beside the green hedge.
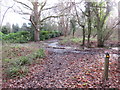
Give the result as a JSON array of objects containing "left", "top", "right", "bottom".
[{"left": 14, "top": 0, "right": 62, "bottom": 41}]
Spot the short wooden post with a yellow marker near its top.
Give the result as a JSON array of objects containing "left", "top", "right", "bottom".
[{"left": 103, "top": 53, "right": 110, "bottom": 80}]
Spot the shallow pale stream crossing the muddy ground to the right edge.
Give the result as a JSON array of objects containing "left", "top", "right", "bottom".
[{"left": 44, "top": 39, "right": 120, "bottom": 58}]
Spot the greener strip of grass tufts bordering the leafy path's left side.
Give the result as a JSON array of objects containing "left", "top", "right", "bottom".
[{"left": 3, "top": 48, "right": 45, "bottom": 79}]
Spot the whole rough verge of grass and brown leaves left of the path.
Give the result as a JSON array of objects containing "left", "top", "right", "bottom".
[{"left": 2, "top": 46, "right": 45, "bottom": 79}]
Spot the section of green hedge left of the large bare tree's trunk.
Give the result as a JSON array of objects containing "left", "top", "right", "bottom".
[{"left": 3, "top": 31, "right": 31, "bottom": 43}]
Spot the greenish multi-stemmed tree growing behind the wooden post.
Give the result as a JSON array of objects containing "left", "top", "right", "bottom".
[{"left": 92, "top": 0, "right": 111, "bottom": 47}]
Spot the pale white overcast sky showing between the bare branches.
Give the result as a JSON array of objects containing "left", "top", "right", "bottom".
[{"left": 0, "top": 0, "right": 120, "bottom": 26}]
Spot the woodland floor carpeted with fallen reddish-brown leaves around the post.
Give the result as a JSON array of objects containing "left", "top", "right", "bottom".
[{"left": 2, "top": 39, "right": 120, "bottom": 89}]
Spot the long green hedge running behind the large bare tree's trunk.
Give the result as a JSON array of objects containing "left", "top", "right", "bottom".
[{"left": 0, "top": 30, "right": 62, "bottom": 43}]
